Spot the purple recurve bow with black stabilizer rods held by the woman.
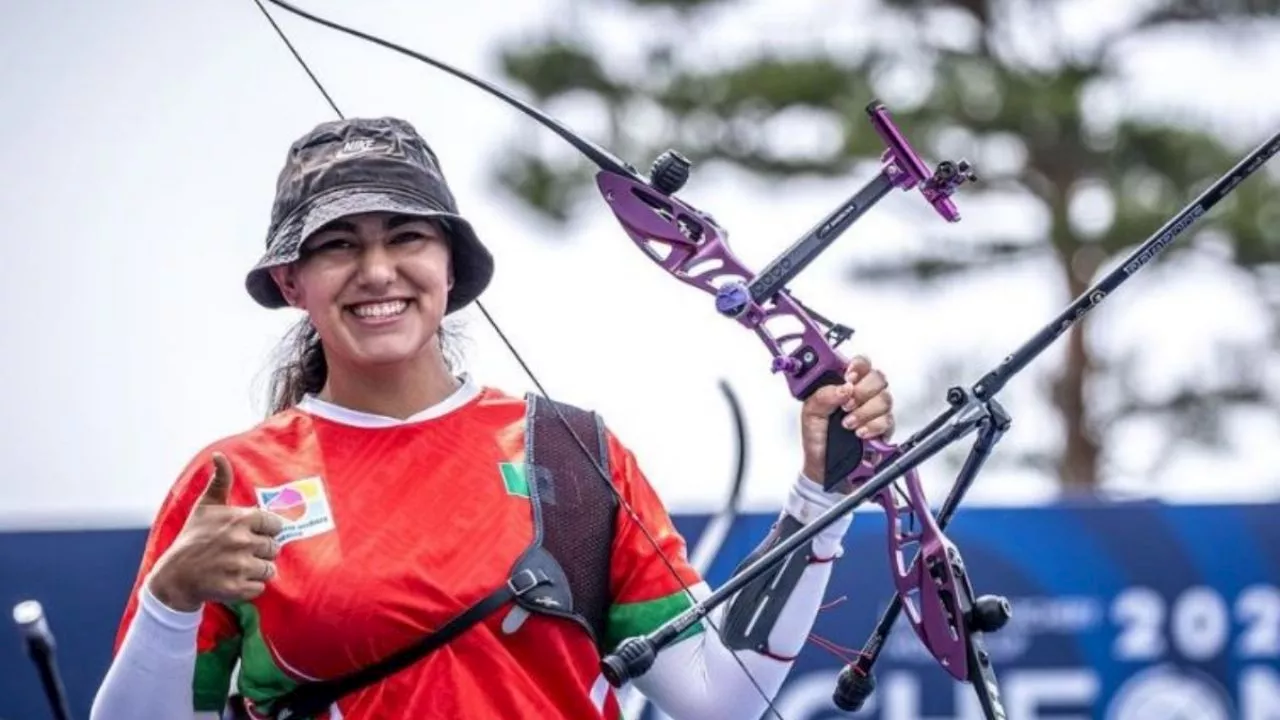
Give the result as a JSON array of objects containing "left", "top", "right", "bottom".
[{"left": 255, "top": 0, "right": 1280, "bottom": 720}]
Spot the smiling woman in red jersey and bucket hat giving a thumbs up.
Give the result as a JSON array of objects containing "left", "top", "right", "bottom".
[{"left": 91, "top": 118, "right": 893, "bottom": 720}]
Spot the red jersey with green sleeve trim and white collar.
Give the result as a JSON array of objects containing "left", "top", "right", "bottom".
[{"left": 116, "top": 379, "right": 700, "bottom": 720}]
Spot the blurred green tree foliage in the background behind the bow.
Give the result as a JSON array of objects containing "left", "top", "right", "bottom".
[{"left": 486, "top": 0, "right": 1280, "bottom": 491}]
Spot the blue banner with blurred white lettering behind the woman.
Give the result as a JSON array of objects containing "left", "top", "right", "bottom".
[{"left": 0, "top": 503, "right": 1280, "bottom": 720}]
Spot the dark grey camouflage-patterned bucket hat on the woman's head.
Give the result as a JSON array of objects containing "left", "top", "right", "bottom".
[{"left": 244, "top": 118, "right": 493, "bottom": 314}]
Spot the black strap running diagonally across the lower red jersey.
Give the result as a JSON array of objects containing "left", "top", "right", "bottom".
[{"left": 271, "top": 568, "right": 552, "bottom": 720}]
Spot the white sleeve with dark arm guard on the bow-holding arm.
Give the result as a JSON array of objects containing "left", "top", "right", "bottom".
[{"left": 634, "top": 475, "right": 852, "bottom": 720}]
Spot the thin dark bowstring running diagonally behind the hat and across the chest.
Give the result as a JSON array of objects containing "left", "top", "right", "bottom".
[{"left": 245, "top": 0, "right": 785, "bottom": 720}]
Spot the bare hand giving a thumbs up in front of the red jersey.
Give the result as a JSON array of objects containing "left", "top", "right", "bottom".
[{"left": 148, "top": 452, "right": 284, "bottom": 612}]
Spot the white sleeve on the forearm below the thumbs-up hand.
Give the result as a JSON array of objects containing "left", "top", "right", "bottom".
[{"left": 90, "top": 584, "right": 219, "bottom": 720}]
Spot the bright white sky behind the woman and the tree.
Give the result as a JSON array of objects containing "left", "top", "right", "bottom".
[{"left": 0, "top": 0, "right": 1280, "bottom": 528}]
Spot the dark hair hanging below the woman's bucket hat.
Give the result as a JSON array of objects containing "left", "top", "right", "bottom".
[{"left": 268, "top": 318, "right": 462, "bottom": 415}]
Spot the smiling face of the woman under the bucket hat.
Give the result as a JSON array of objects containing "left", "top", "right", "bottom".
[{"left": 271, "top": 213, "right": 453, "bottom": 369}]
